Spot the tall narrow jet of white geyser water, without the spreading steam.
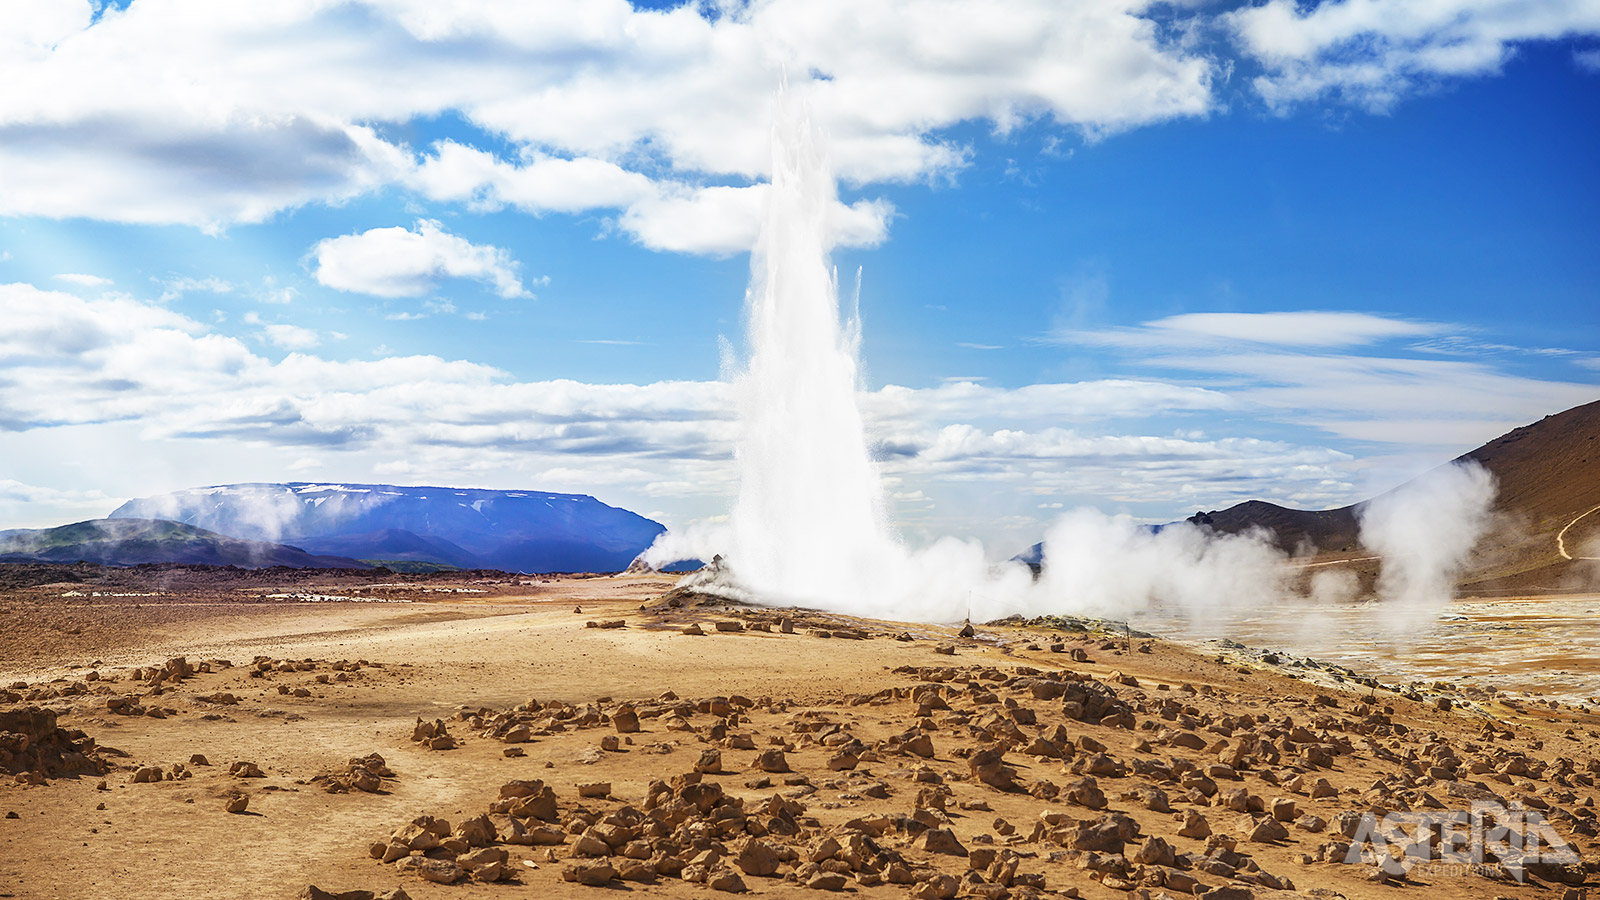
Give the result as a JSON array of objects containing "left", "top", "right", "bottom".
[{"left": 726, "top": 94, "right": 899, "bottom": 602}]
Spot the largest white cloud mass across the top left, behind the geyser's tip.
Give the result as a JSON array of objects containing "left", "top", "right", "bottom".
[{"left": 0, "top": 0, "right": 1216, "bottom": 241}]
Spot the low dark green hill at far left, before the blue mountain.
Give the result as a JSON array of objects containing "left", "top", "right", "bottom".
[{"left": 0, "top": 519, "right": 371, "bottom": 569}]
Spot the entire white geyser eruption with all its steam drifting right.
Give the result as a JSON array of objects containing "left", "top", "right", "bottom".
[{"left": 643, "top": 94, "right": 1493, "bottom": 631}]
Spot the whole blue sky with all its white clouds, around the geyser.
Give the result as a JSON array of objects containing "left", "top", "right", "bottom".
[{"left": 0, "top": 0, "right": 1600, "bottom": 552}]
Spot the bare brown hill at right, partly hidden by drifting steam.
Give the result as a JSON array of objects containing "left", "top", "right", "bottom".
[{"left": 1189, "top": 400, "right": 1600, "bottom": 593}]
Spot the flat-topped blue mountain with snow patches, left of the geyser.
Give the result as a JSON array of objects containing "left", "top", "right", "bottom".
[{"left": 112, "top": 482, "right": 666, "bottom": 572}]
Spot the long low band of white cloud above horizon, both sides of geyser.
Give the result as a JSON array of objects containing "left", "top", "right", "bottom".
[{"left": 0, "top": 285, "right": 1594, "bottom": 531}]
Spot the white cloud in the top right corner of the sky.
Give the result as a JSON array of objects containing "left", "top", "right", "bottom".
[{"left": 1224, "top": 0, "right": 1600, "bottom": 110}]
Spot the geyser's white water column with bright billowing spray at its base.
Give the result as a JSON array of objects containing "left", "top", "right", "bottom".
[{"left": 643, "top": 93, "right": 1032, "bottom": 621}]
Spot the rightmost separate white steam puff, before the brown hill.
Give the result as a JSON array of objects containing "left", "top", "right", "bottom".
[{"left": 1357, "top": 460, "right": 1494, "bottom": 631}]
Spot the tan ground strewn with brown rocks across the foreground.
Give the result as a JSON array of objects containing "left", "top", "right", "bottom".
[{"left": 0, "top": 578, "right": 1600, "bottom": 900}]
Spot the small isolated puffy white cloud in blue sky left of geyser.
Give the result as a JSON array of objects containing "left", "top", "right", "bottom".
[{"left": 312, "top": 219, "right": 530, "bottom": 298}]
